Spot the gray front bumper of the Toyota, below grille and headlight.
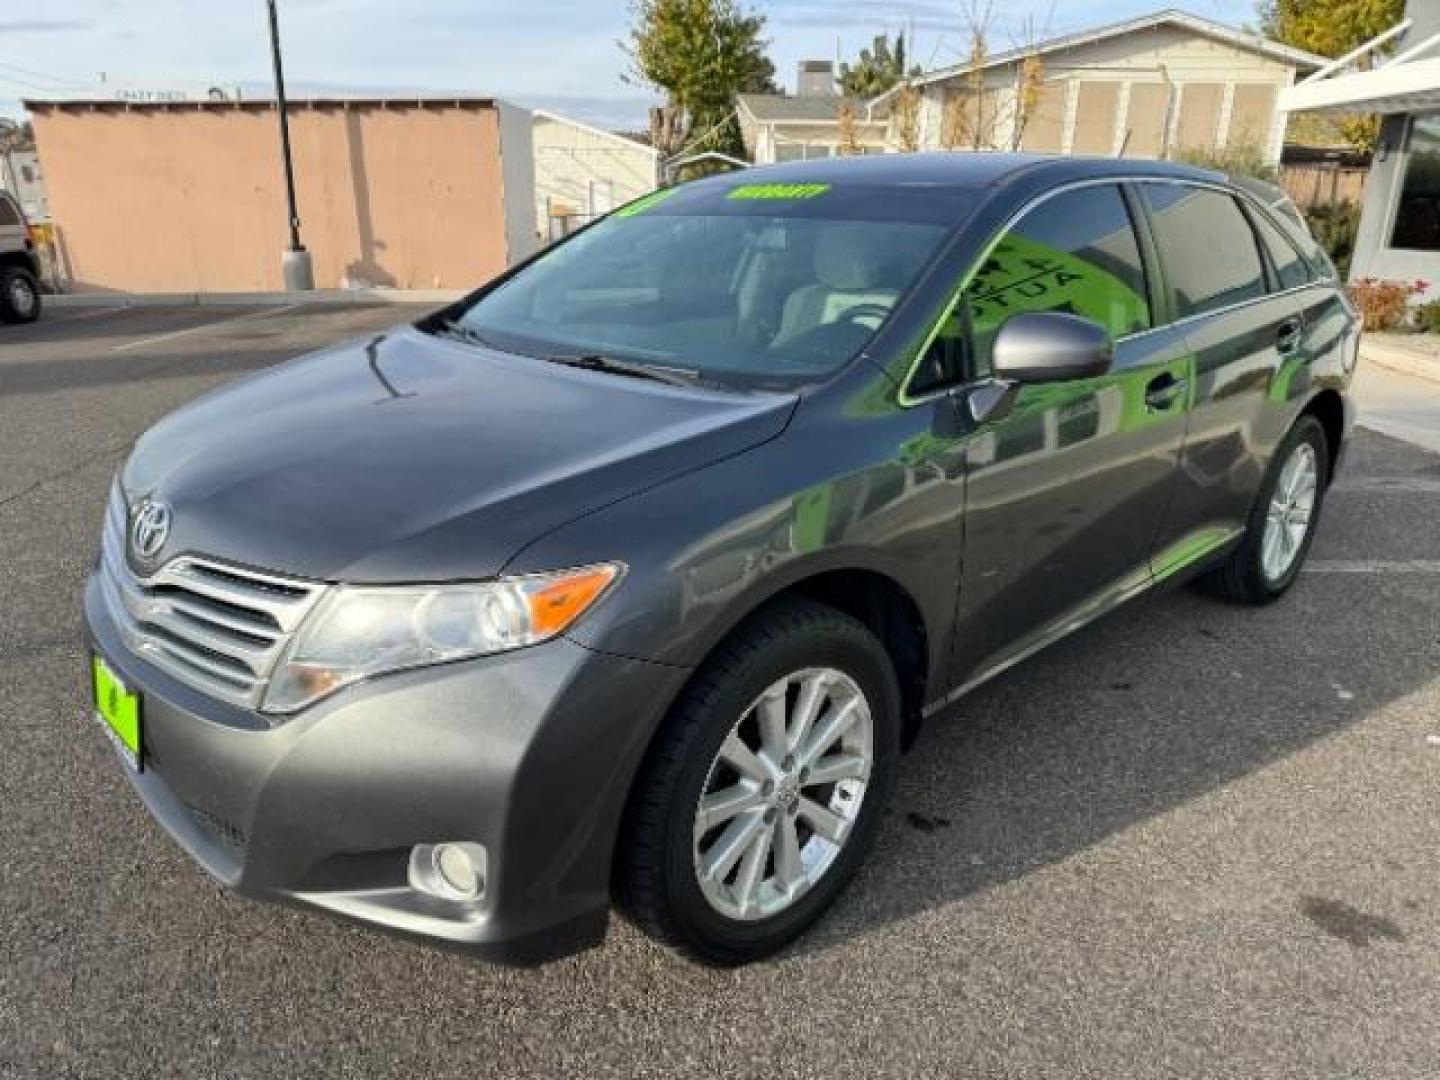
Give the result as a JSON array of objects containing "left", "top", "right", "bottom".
[{"left": 85, "top": 579, "right": 687, "bottom": 963}]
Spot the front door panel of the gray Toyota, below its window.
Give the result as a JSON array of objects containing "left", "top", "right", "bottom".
[{"left": 949, "top": 328, "right": 1189, "bottom": 685}]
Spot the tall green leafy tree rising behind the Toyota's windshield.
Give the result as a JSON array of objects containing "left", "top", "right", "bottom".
[{"left": 621, "top": 0, "right": 776, "bottom": 154}]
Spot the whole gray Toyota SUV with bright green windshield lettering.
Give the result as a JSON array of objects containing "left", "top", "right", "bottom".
[{"left": 85, "top": 154, "right": 1358, "bottom": 963}]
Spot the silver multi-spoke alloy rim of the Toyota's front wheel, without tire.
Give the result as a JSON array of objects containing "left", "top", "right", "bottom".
[{"left": 694, "top": 668, "right": 874, "bottom": 922}]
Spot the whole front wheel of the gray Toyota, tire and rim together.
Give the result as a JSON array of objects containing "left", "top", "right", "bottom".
[{"left": 616, "top": 600, "right": 900, "bottom": 965}]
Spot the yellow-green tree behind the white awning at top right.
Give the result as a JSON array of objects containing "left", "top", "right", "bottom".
[{"left": 1260, "top": 0, "right": 1405, "bottom": 150}]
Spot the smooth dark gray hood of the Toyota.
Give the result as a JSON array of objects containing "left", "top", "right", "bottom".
[{"left": 121, "top": 327, "right": 796, "bottom": 582}]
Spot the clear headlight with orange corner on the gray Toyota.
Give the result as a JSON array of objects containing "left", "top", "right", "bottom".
[{"left": 264, "top": 563, "right": 621, "bottom": 713}]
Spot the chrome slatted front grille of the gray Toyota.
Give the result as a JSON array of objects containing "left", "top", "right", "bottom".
[{"left": 99, "top": 485, "right": 325, "bottom": 708}]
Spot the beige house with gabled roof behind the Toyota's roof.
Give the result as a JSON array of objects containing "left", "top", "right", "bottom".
[{"left": 740, "top": 10, "right": 1325, "bottom": 163}]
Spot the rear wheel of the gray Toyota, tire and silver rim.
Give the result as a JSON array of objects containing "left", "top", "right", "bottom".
[{"left": 1201, "top": 416, "right": 1329, "bottom": 603}]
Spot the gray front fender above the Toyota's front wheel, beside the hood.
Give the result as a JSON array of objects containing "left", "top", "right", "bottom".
[{"left": 505, "top": 397, "right": 963, "bottom": 702}]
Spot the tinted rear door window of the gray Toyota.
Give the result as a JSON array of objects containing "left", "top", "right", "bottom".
[{"left": 1140, "top": 183, "right": 1266, "bottom": 318}]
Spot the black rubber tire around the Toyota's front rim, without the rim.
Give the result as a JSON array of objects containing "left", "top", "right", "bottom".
[{"left": 615, "top": 599, "right": 901, "bottom": 966}]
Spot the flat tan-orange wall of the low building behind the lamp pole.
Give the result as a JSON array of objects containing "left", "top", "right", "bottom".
[{"left": 35, "top": 105, "right": 515, "bottom": 292}]
